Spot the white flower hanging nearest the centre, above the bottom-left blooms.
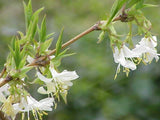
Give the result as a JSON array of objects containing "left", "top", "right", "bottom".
[{"left": 37, "top": 67, "right": 79, "bottom": 94}]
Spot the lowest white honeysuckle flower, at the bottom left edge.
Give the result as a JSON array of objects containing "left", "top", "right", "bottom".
[{"left": 12, "top": 96, "right": 54, "bottom": 120}]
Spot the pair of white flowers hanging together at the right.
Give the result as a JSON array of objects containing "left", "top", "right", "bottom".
[{"left": 113, "top": 36, "right": 159, "bottom": 78}]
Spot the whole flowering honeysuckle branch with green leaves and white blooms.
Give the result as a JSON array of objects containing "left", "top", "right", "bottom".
[{"left": 0, "top": 0, "right": 159, "bottom": 119}]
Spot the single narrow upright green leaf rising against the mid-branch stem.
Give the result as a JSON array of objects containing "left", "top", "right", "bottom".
[{"left": 55, "top": 28, "right": 64, "bottom": 56}]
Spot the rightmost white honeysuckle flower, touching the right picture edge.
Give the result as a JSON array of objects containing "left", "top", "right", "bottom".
[{"left": 132, "top": 36, "right": 159, "bottom": 63}]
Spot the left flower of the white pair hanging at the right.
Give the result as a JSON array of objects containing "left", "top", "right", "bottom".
[{"left": 113, "top": 45, "right": 138, "bottom": 78}]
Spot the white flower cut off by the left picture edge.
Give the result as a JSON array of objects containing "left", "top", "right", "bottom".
[{"left": 0, "top": 78, "right": 9, "bottom": 102}]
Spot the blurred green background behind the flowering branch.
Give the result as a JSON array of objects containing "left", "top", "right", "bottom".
[{"left": 0, "top": 0, "right": 160, "bottom": 120}]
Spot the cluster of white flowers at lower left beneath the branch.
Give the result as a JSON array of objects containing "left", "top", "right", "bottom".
[{"left": 0, "top": 63, "right": 79, "bottom": 120}]
